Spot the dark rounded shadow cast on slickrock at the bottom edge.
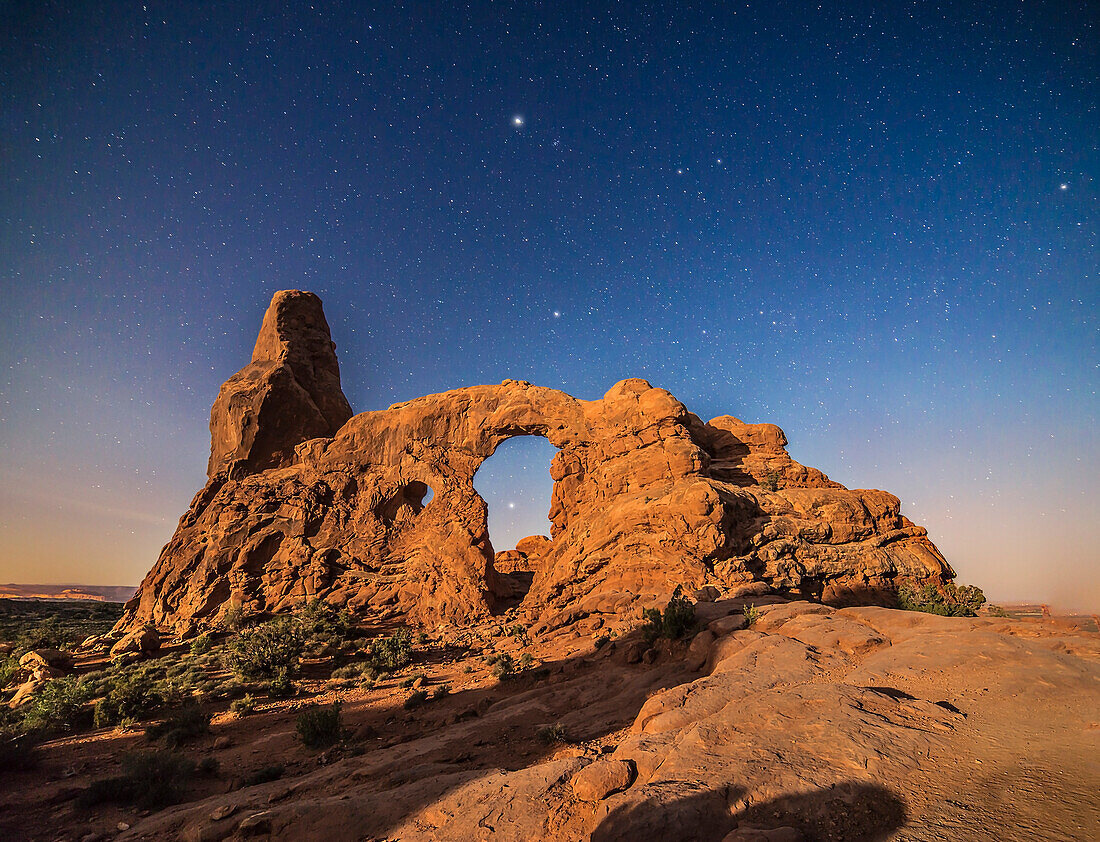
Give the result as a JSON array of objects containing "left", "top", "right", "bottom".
[{"left": 591, "top": 781, "right": 906, "bottom": 842}]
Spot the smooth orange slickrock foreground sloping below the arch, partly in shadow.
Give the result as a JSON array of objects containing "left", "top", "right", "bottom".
[{"left": 99, "top": 601, "right": 1100, "bottom": 842}]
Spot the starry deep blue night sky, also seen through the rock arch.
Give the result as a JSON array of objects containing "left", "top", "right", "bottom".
[{"left": 0, "top": 0, "right": 1100, "bottom": 610}]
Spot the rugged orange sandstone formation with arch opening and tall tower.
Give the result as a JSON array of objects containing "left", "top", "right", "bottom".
[{"left": 118, "top": 292, "right": 954, "bottom": 635}]
